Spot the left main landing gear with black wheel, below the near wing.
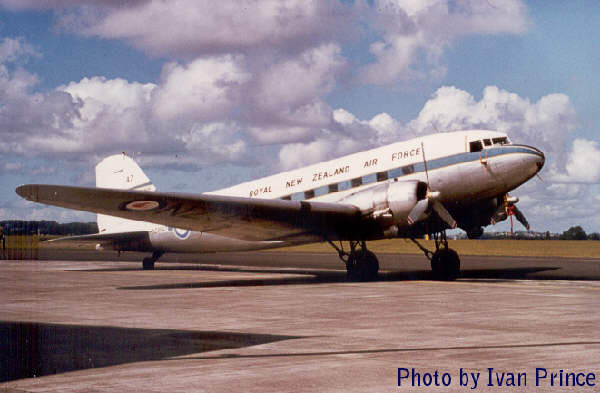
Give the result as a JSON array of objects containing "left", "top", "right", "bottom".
[{"left": 329, "top": 237, "right": 379, "bottom": 281}]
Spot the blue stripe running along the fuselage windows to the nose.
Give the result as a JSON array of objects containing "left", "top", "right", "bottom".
[{"left": 281, "top": 146, "right": 543, "bottom": 201}]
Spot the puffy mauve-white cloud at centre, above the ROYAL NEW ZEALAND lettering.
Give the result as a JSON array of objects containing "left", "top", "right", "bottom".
[{"left": 242, "top": 44, "right": 346, "bottom": 144}]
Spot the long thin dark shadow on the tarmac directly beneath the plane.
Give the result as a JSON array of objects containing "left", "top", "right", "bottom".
[{"left": 118, "top": 266, "right": 564, "bottom": 290}]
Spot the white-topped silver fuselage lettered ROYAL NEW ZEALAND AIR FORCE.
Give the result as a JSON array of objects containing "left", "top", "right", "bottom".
[{"left": 142, "top": 130, "right": 544, "bottom": 252}]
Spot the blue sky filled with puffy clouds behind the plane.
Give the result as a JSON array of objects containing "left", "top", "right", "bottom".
[{"left": 0, "top": 0, "right": 600, "bottom": 232}]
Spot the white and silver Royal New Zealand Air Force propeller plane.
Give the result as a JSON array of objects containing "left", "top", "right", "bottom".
[{"left": 16, "top": 130, "right": 545, "bottom": 280}]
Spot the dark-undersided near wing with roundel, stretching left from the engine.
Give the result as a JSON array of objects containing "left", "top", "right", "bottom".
[{"left": 16, "top": 184, "right": 365, "bottom": 242}]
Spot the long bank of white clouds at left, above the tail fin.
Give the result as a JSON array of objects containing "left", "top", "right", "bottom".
[{"left": 0, "top": 47, "right": 249, "bottom": 167}]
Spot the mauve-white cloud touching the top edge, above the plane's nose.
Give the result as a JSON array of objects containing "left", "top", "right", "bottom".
[{"left": 360, "top": 0, "right": 527, "bottom": 85}]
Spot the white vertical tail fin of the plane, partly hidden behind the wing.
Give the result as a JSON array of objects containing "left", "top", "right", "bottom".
[{"left": 96, "top": 153, "right": 156, "bottom": 233}]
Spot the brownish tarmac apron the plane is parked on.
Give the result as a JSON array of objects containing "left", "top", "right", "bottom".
[{"left": 0, "top": 251, "right": 600, "bottom": 392}]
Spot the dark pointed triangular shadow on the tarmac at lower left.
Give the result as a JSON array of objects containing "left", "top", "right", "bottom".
[{"left": 0, "top": 321, "right": 299, "bottom": 382}]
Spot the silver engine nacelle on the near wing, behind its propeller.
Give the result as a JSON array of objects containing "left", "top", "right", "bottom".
[{"left": 340, "top": 180, "right": 427, "bottom": 225}]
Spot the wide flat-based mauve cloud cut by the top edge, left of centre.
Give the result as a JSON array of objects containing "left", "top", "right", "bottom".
[{"left": 57, "top": 0, "right": 353, "bottom": 58}]
